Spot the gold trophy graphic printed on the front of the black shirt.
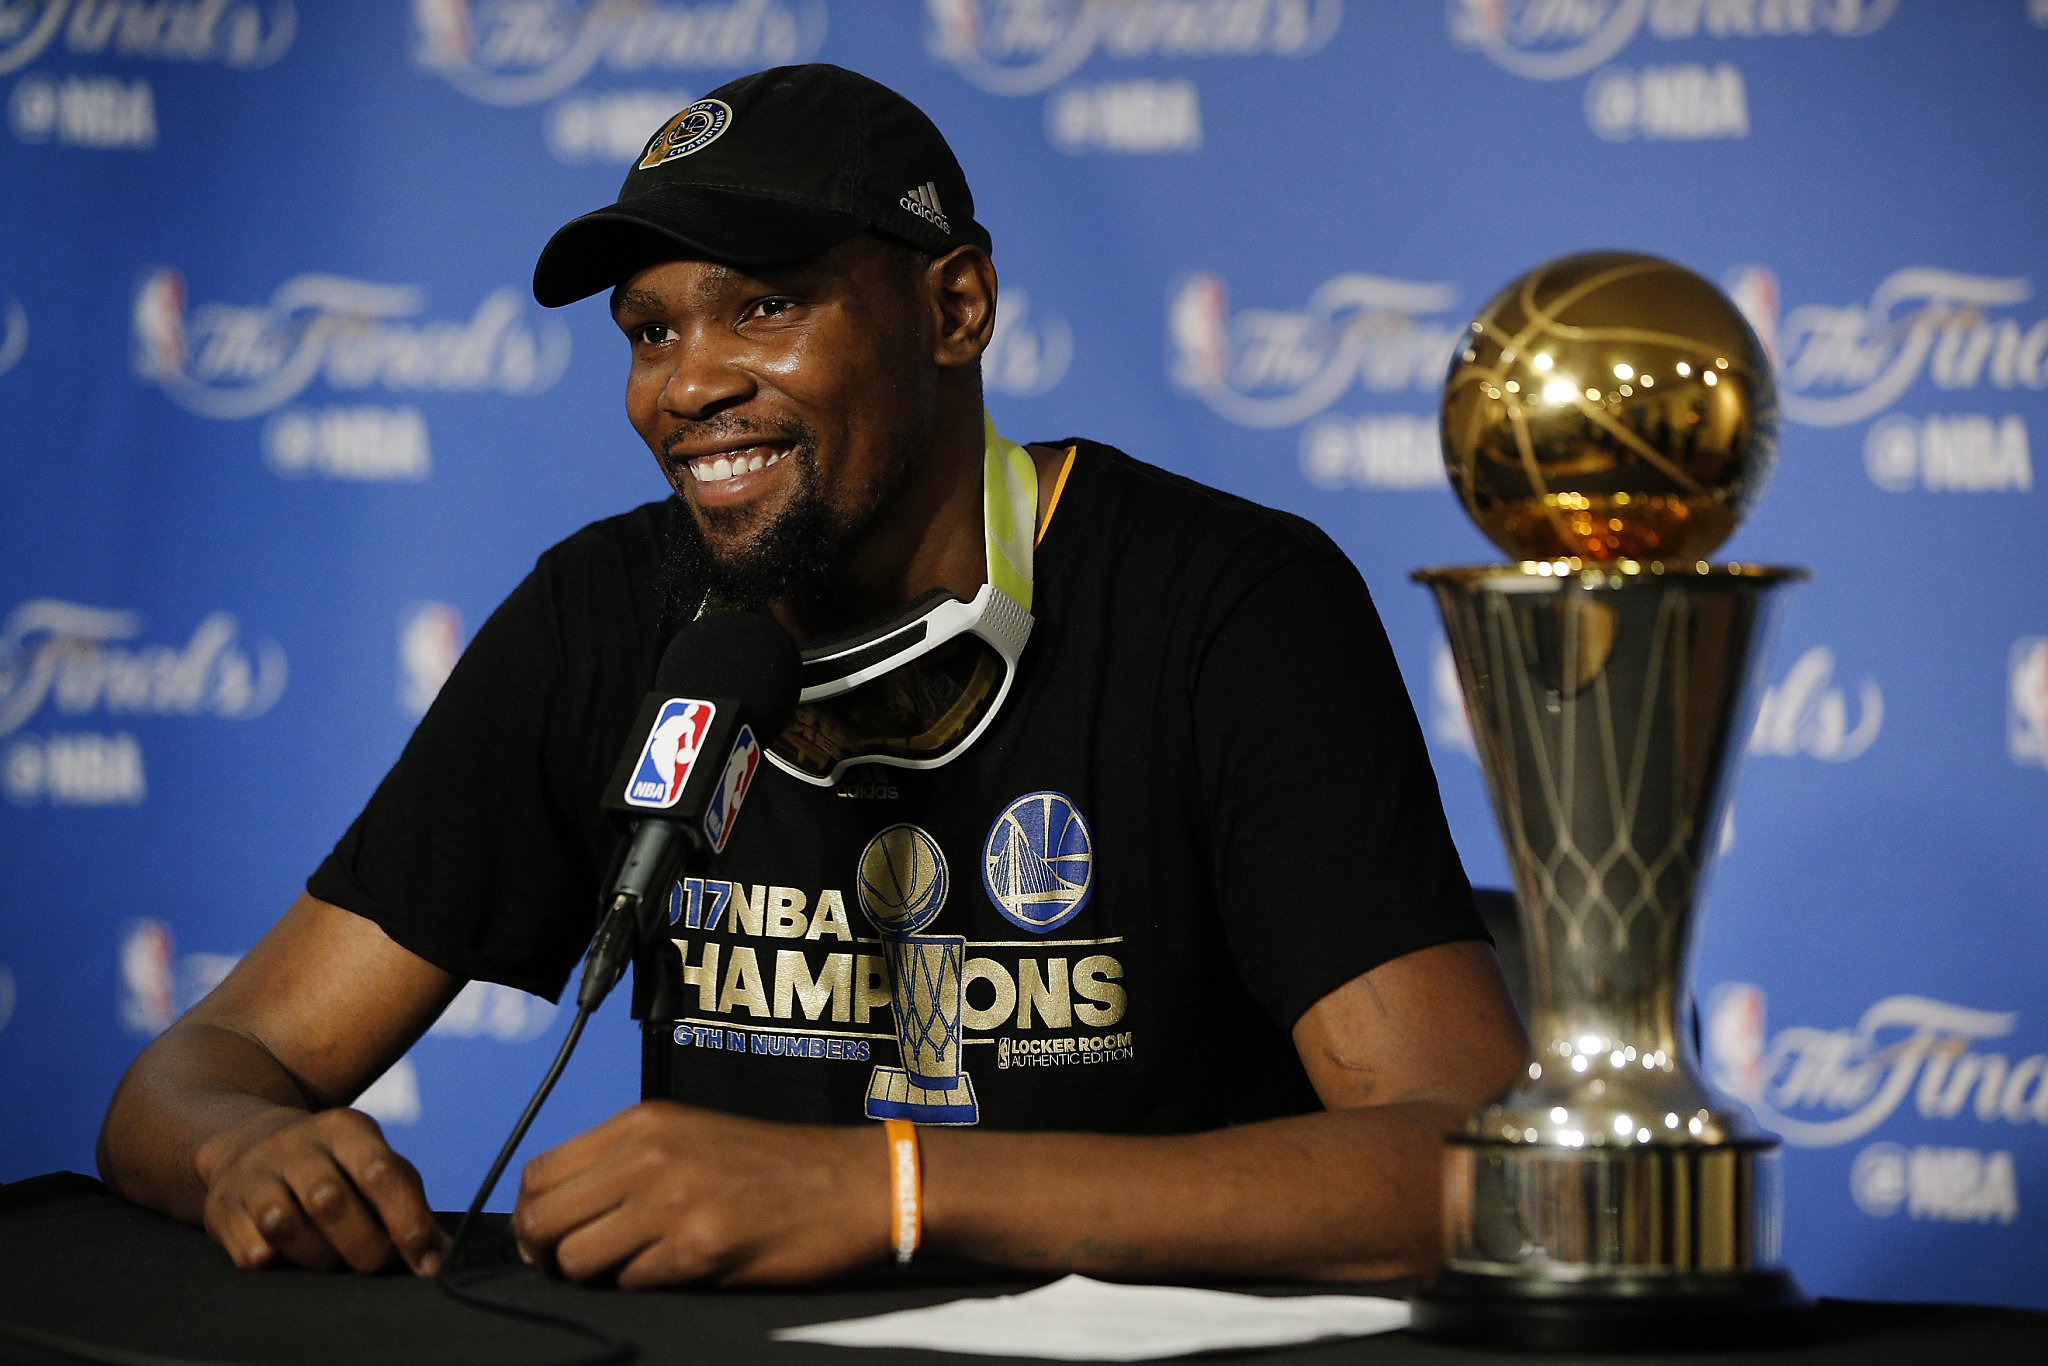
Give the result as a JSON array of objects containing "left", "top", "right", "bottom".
[{"left": 856, "top": 825, "right": 981, "bottom": 1124}]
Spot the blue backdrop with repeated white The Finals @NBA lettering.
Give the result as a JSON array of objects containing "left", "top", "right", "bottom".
[{"left": 0, "top": 0, "right": 2048, "bottom": 1307}]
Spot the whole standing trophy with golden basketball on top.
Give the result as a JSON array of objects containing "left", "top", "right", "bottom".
[{"left": 1415, "top": 252, "right": 1806, "bottom": 1348}]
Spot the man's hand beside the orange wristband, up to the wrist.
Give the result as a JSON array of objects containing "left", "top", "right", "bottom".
[{"left": 512, "top": 1100, "right": 889, "bottom": 1288}]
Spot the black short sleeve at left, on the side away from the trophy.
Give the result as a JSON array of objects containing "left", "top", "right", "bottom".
[{"left": 307, "top": 507, "right": 651, "bottom": 999}]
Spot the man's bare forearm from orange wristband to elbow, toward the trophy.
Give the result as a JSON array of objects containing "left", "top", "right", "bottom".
[{"left": 922, "top": 1102, "right": 1466, "bottom": 1280}]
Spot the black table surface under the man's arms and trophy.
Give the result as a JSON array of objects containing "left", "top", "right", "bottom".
[{"left": 0, "top": 1173, "right": 2048, "bottom": 1366}]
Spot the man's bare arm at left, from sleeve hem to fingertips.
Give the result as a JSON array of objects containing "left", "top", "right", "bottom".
[{"left": 98, "top": 895, "right": 463, "bottom": 1272}]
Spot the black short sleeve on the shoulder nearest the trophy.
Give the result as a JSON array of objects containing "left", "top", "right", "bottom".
[{"left": 1194, "top": 524, "right": 1485, "bottom": 1028}]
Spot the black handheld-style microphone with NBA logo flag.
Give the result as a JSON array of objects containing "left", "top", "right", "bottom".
[{"left": 575, "top": 612, "right": 799, "bottom": 1012}]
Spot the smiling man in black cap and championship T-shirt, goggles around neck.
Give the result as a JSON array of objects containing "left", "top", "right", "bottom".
[{"left": 100, "top": 66, "right": 1524, "bottom": 1286}]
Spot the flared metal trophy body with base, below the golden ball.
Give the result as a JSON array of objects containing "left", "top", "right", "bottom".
[{"left": 1415, "top": 563, "right": 1806, "bottom": 1348}]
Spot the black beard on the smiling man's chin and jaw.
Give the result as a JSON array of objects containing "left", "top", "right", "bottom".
[{"left": 662, "top": 430, "right": 909, "bottom": 623}]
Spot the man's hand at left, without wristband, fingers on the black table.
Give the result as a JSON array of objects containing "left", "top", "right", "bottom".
[{"left": 195, "top": 1108, "right": 449, "bottom": 1276}]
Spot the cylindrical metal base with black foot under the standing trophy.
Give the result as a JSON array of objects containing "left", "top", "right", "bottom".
[{"left": 1411, "top": 1135, "right": 1815, "bottom": 1352}]
